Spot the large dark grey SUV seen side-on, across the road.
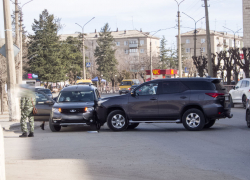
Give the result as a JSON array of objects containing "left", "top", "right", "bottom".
[{"left": 96, "top": 78, "right": 232, "bottom": 131}]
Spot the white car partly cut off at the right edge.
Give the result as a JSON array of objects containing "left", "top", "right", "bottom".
[{"left": 229, "top": 78, "right": 250, "bottom": 108}]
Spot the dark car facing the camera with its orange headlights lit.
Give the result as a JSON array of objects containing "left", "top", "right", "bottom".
[{"left": 49, "top": 85, "right": 101, "bottom": 132}]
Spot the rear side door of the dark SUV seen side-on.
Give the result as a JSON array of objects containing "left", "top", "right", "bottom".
[{"left": 158, "top": 81, "right": 190, "bottom": 120}]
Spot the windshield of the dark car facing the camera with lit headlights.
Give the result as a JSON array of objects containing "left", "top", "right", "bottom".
[{"left": 58, "top": 91, "right": 94, "bottom": 102}]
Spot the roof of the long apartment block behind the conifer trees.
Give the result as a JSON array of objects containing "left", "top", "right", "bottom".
[{"left": 60, "top": 30, "right": 160, "bottom": 40}]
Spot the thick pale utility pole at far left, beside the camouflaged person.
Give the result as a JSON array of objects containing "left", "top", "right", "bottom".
[{"left": 3, "top": 0, "right": 18, "bottom": 121}]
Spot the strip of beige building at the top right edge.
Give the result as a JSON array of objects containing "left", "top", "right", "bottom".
[{"left": 242, "top": 0, "right": 250, "bottom": 48}]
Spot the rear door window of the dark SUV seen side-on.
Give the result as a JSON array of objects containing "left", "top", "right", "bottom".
[{"left": 161, "top": 81, "right": 187, "bottom": 94}]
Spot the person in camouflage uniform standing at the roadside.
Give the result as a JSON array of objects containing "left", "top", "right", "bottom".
[{"left": 19, "top": 96, "right": 36, "bottom": 137}]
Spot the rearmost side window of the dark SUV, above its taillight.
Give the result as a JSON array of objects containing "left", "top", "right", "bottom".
[{"left": 183, "top": 81, "right": 216, "bottom": 90}]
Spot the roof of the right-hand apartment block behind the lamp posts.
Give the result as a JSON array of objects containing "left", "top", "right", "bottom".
[{"left": 179, "top": 28, "right": 243, "bottom": 39}]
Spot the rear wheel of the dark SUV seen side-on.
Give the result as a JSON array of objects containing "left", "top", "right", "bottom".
[{"left": 182, "top": 109, "right": 205, "bottom": 131}]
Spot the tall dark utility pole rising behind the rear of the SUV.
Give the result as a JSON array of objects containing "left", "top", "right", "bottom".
[{"left": 204, "top": 0, "right": 213, "bottom": 77}]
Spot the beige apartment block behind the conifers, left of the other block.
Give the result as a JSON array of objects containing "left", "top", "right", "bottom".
[{"left": 60, "top": 30, "right": 160, "bottom": 71}]
